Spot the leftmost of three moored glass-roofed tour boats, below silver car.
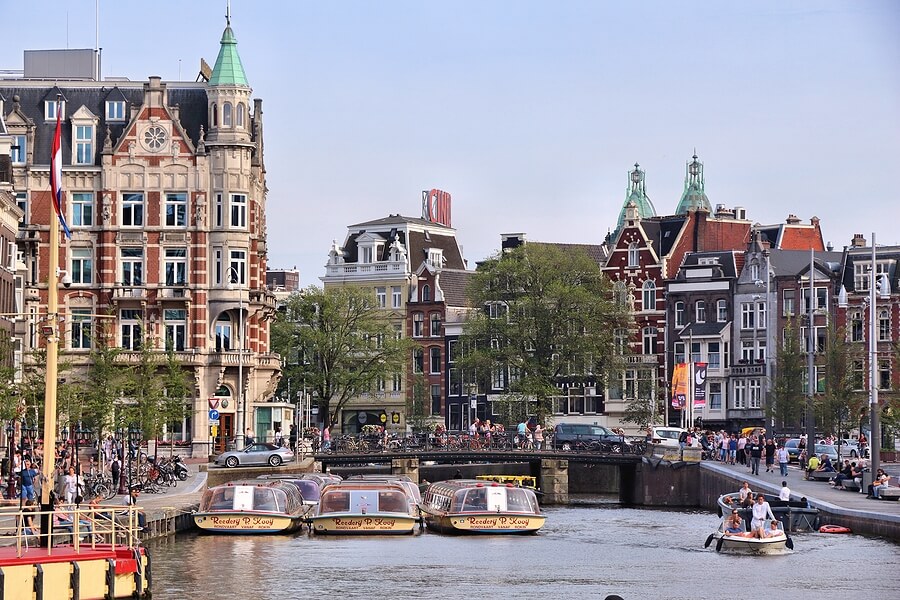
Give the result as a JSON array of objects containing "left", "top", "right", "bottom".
[{"left": 194, "top": 479, "right": 310, "bottom": 534}]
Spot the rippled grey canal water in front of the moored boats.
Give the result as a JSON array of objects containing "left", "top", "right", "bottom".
[{"left": 149, "top": 505, "right": 900, "bottom": 600}]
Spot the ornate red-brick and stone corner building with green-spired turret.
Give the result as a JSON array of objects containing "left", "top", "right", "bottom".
[{"left": 0, "top": 19, "right": 280, "bottom": 454}]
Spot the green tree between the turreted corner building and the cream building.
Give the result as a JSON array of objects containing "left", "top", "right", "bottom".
[{"left": 276, "top": 286, "right": 411, "bottom": 427}]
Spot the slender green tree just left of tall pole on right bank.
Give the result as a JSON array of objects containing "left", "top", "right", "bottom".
[{"left": 766, "top": 318, "right": 807, "bottom": 430}]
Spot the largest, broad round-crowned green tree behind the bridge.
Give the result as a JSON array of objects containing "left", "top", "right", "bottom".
[{"left": 461, "top": 244, "right": 631, "bottom": 423}]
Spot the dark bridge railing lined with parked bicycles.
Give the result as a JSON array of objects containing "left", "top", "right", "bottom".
[{"left": 312, "top": 431, "right": 646, "bottom": 455}]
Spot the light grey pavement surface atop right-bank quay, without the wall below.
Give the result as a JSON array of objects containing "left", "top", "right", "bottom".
[{"left": 701, "top": 460, "right": 900, "bottom": 523}]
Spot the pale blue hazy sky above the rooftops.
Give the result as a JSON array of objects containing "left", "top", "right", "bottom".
[{"left": 0, "top": 0, "right": 900, "bottom": 286}]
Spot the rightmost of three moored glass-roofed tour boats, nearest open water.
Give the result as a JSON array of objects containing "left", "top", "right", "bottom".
[{"left": 422, "top": 479, "right": 546, "bottom": 533}]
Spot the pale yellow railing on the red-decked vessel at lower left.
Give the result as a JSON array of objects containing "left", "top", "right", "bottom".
[{"left": 0, "top": 504, "right": 142, "bottom": 557}]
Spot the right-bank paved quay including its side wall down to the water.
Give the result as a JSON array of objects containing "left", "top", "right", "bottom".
[{"left": 701, "top": 460, "right": 900, "bottom": 539}]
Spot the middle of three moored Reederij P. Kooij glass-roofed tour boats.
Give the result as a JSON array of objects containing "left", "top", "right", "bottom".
[{"left": 309, "top": 480, "right": 420, "bottom": 535}]
